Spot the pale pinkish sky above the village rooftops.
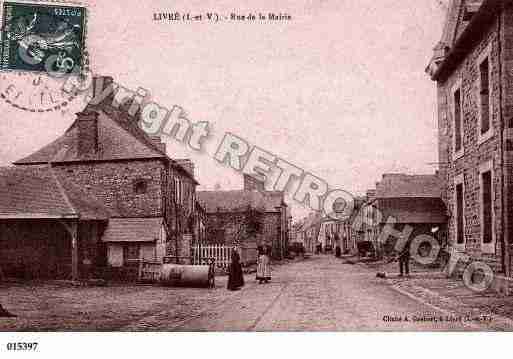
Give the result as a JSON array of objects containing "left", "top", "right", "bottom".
[{"left": 0, "top": 0, "right": 445, "bottom": 216}]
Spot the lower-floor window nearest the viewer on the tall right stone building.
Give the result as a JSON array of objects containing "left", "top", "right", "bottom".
[{"left": 479, "top": 161, "right": 495, "bottom": 253}]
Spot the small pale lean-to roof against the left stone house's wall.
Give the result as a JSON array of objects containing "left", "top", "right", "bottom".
[{"left": 102, "top": 217, "right": 163, "bottom": 242}]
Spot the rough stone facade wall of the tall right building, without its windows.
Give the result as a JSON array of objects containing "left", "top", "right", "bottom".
[{"left": 437, "top": 16, "right": 502, "bottom": 268}]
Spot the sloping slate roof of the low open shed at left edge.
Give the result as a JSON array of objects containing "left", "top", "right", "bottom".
[{"left": 0, "top": 166, "right": 111, "bottom": 220}]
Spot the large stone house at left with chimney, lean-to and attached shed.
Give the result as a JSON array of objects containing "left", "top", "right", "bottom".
[{"left": 0, "top": 78, "right": 199, "bottom": 279}]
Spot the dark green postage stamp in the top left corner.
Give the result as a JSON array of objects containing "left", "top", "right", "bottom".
[{"left": 0, "top": 2, "right": 86, "bottom": 73}]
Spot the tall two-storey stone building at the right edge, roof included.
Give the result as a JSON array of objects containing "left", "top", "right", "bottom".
[{"left": 426, "top": 0, "right": 513, "bottom": 275}]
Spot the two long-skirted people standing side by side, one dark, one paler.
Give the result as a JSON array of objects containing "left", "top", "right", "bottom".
[{"left": 227, "top": 246, "right": 271, "bottom": 290}]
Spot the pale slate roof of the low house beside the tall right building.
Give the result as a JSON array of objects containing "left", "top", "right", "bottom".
[{"left": 376, "top": 173, "right": 442, "bottom": 199}]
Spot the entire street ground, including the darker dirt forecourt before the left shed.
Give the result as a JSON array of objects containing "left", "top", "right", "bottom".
[{"left": 4, "top": 255, "right": 504, "bottom": 331}]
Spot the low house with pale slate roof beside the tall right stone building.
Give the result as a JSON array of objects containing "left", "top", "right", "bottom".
[{"left": 371, "top": 174, "right": 447, "bottom": 253}]
